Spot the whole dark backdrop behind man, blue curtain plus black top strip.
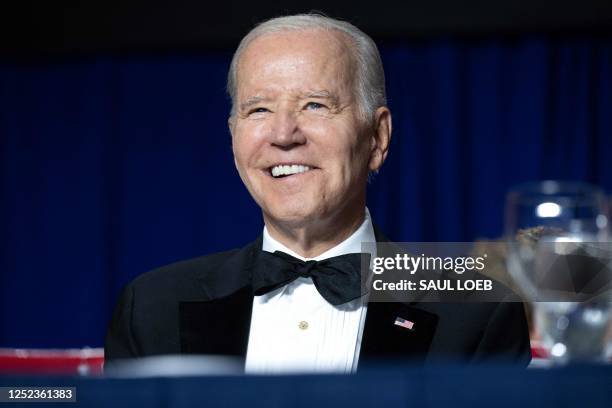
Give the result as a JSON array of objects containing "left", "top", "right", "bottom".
[{"left": 0, "top": 0, "right": 612, "bottom": 347}]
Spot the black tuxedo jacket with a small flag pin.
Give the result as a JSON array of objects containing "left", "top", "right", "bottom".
[{"left": 105, "top": 232, "right": 531, "bottom": 367}]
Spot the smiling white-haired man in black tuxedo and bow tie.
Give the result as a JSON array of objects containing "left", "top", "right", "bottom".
[{"left": 105, "top": 15, "right": 529, "bottom": 373}]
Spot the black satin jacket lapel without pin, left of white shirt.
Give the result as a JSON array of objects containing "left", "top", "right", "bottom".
[{"left": 179, "top": 237, "right": 261, "bottom": 357}]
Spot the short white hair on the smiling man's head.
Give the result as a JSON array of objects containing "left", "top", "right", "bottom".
[{"left": 227, "top": 13, "right": 387, "bottom": 120}]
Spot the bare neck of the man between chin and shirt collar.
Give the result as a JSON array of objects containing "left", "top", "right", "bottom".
[{"left": 264, "top": 206, "right": 365, "bottom": 258}]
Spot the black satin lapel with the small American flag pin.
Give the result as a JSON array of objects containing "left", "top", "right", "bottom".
[{"left": 360, "top": 226, "right": 438, "bottom": 362}]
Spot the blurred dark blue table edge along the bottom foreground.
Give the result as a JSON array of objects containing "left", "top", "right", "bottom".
[{"left": 0, "top": 364, "right": 612, "bottom": 408}]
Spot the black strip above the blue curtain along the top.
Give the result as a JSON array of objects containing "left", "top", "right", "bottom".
[{"left": 0, "top": 0, "right": 612, "bottom": 55}]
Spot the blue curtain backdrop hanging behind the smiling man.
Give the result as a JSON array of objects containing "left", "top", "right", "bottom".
[{"left": 0, "top": 38, "right": 612, "bottom": 347}]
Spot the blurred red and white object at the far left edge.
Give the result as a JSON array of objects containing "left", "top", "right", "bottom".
[{"left": 0, "top": 348, "right": 104, "bottom": 375}]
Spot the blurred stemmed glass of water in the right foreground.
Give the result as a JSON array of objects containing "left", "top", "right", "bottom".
[{"left": 505, "top": 181, "right": 612, "bottom": 364}]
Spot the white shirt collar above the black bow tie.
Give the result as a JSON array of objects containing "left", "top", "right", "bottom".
[{"left": 262, "top": 208, "right": 376, "bottom": 261}]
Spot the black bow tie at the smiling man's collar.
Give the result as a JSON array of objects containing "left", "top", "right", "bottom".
[{"left": 253, "top": 251, "right": 370, "bottom": 306}]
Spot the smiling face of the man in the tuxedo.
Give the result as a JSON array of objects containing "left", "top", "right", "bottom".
[{"left": 230, "top": 30, "right": 372, "bottom": 227}]
